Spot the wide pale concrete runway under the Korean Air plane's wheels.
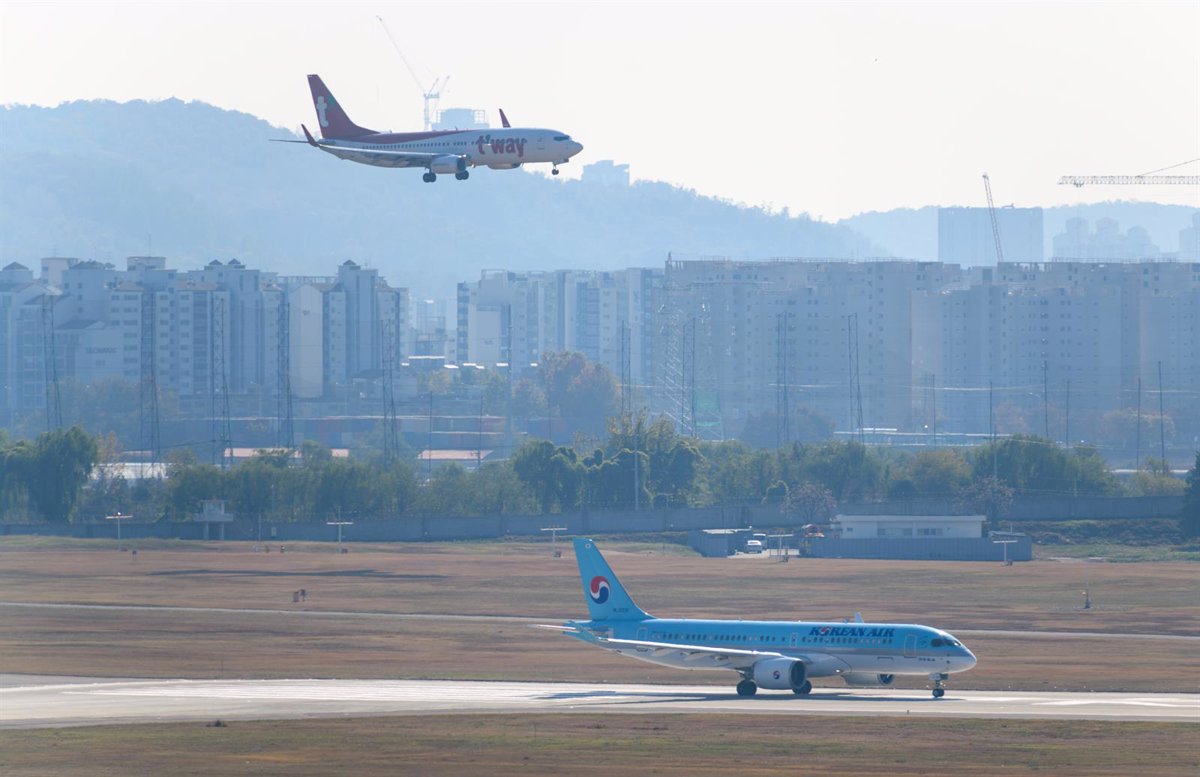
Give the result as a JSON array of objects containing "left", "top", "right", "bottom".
[{"left": 0, "top": 675, "right": 1200, "bottom": 729}]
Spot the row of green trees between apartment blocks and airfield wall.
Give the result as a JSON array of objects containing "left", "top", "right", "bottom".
[{"left": 0, "top": 422, "right": 1200, "bottom": 537}]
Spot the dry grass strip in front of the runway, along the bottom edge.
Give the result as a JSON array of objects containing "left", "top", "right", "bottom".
[{"left": 0, "top": 715, "right": 1200, "bottom": 777}]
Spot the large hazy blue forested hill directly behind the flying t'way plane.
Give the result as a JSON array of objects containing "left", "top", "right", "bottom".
[{"left": 0, "top": 100, "right": 882, "bottom": 295}]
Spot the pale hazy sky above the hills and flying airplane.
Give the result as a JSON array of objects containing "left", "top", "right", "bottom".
[{"left": 0, "top": 0, "right": 1200, "bottom": 219}]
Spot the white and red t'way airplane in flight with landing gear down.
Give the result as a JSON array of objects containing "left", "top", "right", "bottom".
[{"left": 294, "top": 76, "right": 583, "bottom": 183}]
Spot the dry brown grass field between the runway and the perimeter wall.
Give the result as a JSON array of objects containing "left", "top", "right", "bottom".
[{"left": 0, "top": 538, "right": 1200, "bottom": 691}]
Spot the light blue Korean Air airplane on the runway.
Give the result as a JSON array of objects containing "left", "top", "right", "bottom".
[{"left": 539, "top": 538, "right": 976, "bottom": 699}]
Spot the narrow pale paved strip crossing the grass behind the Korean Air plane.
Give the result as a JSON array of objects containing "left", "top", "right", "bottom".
[{"left": 0, "top": 602, "right": 1200, "bottom": 643}]
